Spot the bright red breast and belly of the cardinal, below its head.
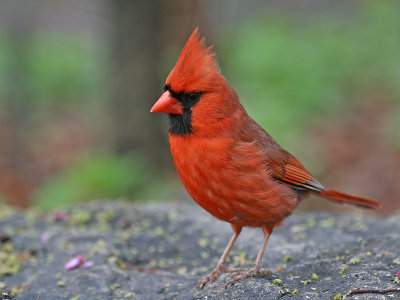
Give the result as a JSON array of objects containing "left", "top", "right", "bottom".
[{"left": 169, "top": 135, "right": 297, "bottom": 227}]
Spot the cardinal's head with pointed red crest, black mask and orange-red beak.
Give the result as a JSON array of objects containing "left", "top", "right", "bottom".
[{"left": 151, "top": 28, "right": 239, "bottom": 135}]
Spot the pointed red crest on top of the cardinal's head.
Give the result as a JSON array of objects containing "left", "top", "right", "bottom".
[{"left": 166, "top": 28, "right": 220, "bottom": 92}]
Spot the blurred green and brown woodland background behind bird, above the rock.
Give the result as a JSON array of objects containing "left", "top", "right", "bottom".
[{"left": 0, "top": 0, "right": 400, "bottom": 214}]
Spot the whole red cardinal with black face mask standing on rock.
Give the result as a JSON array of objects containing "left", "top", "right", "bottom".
[{"left": 151, "top": 28, "right": 380, "bottom": 286}]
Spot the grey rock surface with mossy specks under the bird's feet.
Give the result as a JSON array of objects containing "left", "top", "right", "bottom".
[{"left": 0, "top": 201, "right": 400, "bottom": 300}]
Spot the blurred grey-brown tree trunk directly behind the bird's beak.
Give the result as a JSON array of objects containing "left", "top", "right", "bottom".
[{"left": 109, "top": 0, "right": 169, "bottom": 166}]
